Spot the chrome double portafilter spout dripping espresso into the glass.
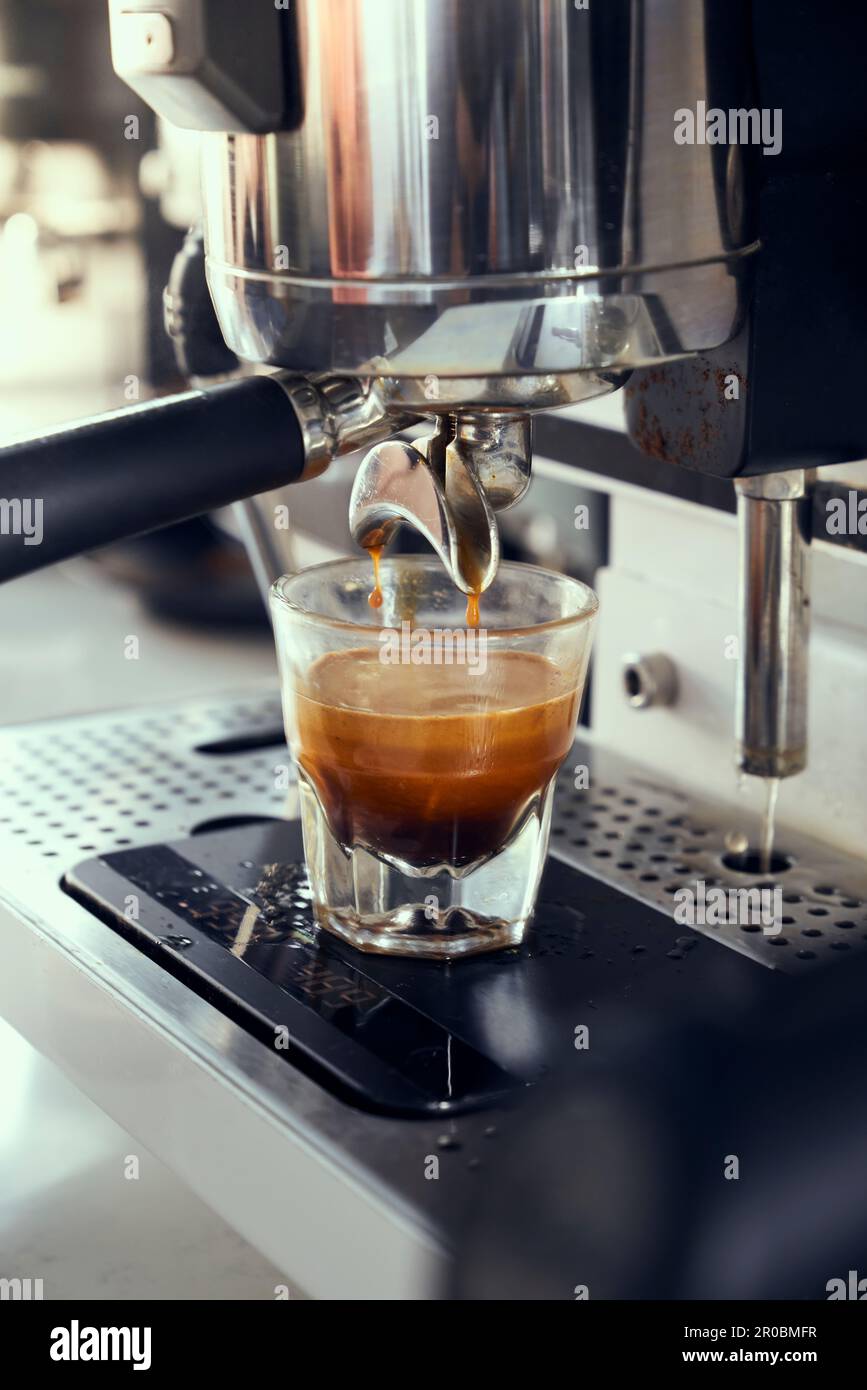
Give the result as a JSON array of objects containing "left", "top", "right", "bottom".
[{"left": 349, "top": 411, "right": 532, "bottom": 594}]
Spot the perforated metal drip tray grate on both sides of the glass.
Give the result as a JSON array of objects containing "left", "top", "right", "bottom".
[{"left": 0, "top": 695, "right": 867, "bottom": 970}]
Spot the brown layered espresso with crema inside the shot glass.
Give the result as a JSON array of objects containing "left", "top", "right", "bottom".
[{"left": 296, "top": 649, "right": 578, "bottom": 872}]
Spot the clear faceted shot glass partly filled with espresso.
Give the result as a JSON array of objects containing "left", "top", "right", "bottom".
[{"left": 271, "top": 556, "right": 597, "bottom": 959}]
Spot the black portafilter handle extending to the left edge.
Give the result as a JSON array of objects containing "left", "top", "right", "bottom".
[{"left": 0, "top": 377, "right": 304, "bottom": 582}]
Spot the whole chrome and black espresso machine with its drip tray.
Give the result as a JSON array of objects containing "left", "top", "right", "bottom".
[{"left": 0, "top": 0, "right": 867, "bottom": 1298}]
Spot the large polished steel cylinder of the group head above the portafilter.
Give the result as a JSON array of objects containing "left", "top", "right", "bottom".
[{"left": 203, "top": 0, "right": 756, "bottom": 410}]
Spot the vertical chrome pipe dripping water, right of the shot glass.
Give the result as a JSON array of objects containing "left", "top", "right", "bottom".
[{"left": 735, "top": 470, "right": 810, "bottom": 777}]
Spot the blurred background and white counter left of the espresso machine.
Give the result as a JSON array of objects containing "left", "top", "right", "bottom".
[{"left": 0, "top": 0, "right": 291, "bottom": 1298}]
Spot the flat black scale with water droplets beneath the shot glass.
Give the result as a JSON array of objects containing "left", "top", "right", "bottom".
[{"left": 64, "top": 820, "right": 768, "bottom": 1115}]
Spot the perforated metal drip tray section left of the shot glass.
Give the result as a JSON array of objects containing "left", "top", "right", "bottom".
[{"left": 0, "top": 695, "right": 289, "bottom": 877}]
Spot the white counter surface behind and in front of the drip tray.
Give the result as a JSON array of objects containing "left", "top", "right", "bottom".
[{"left": 0, "top": 562, "right": 296, "bottom": 1300}]
